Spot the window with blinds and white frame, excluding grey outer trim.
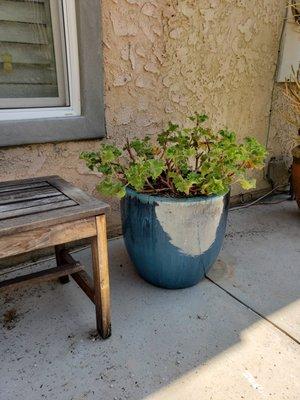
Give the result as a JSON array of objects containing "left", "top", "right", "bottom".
[{"left": 0, "top": 0, "right": 80, "bottom": 120}]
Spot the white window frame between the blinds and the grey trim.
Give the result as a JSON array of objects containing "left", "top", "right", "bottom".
[{"left": 0, "top": 0, "right": 81, "bottom": 121}]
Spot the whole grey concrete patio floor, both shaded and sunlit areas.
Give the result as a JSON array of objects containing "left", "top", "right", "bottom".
[{"left": 0, "top": 201, "right": 300, "bottom": 400}]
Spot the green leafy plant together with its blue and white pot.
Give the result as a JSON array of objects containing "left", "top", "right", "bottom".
[{"left": 81, "top": 113, "right": 266, "bottom": 289}]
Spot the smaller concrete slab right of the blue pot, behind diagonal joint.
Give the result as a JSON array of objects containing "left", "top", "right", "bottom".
[{"left": 208, "top": 201, "right": 300, "bottom": 341}]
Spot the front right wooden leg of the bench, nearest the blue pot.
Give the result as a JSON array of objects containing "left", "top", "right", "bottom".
[{"left": 92, "top": 215, "right": 111, "bottom": 339}]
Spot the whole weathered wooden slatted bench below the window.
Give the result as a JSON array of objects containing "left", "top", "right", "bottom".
[{"left": 0, "top": 176, "right": 111, "bottom": 338}]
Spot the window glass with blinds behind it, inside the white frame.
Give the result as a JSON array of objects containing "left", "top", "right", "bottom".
[{"left": 0, "top": 0, "right": 68, "bottom": 108}]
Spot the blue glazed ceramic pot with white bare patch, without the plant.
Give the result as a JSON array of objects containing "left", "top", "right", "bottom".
[{"left": 121, "top": 189, "right": 229, "bottom": 289}]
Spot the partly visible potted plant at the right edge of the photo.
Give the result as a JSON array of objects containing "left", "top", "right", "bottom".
[{"left": 284, "top": 68, "right": 300, "bottom": 208}]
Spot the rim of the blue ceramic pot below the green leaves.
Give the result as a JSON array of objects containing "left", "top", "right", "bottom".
[{"left": 126, "top": 187, "right": 230, "bottom": 203}]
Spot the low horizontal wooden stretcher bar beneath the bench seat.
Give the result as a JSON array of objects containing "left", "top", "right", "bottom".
[{"left": 0, "top": 263, "right": 83, "bottom": 290}]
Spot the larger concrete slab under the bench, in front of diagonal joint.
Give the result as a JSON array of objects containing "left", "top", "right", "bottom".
[{"left": 0, "top": 240, "right": 300, "bottom": 400}]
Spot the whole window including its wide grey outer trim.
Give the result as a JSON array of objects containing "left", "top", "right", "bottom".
[{"left": 0, "top": 0, "right": 105, "bottom": 146}]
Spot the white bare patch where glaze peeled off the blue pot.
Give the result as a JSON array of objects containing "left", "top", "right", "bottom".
[{"left": 155, "top": 197, "right": 223, "bottom": 256}]
